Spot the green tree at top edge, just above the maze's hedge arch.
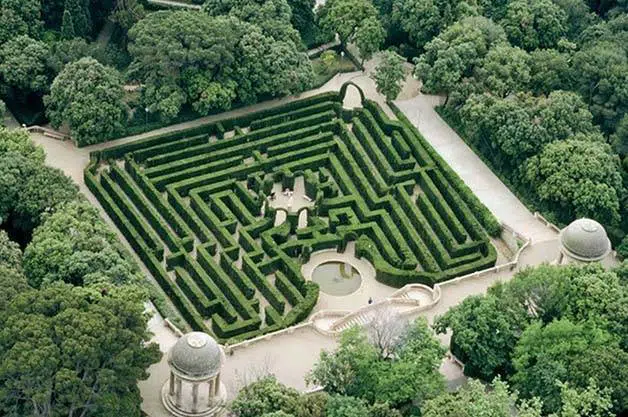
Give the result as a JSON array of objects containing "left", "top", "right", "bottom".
[{"left": 320, "top": 0, "right": 377, "bottom": 49}]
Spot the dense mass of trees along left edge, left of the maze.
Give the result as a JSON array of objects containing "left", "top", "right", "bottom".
[{"left": 0, "top": 128, "right": 160, "bottom": 417}]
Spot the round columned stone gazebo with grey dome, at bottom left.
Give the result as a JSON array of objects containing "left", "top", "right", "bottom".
[{"left": 161, "top": 332, "right": 226, "bottom": 417}]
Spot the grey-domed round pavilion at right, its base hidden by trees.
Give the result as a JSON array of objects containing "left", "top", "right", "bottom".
[{"left": 558, "top": 218, "right": 611, "bottom": 264}]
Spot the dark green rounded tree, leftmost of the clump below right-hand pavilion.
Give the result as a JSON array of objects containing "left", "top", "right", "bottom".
[{"left": 435, "top": 295, "right": 530, "bottom": 381}]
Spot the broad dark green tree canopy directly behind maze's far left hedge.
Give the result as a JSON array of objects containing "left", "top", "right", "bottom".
[{"left": 129, "top": 10, "right": 314, "bottom": 118}]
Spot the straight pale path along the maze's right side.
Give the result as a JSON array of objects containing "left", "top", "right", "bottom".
[{"left": 395, "top": 94, "right": 558, "bottom": 242}]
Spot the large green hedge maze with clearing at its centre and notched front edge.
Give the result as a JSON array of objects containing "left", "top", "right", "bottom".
[{"left": 85, "top": 86, "right": 499, "bottom": 342}]
